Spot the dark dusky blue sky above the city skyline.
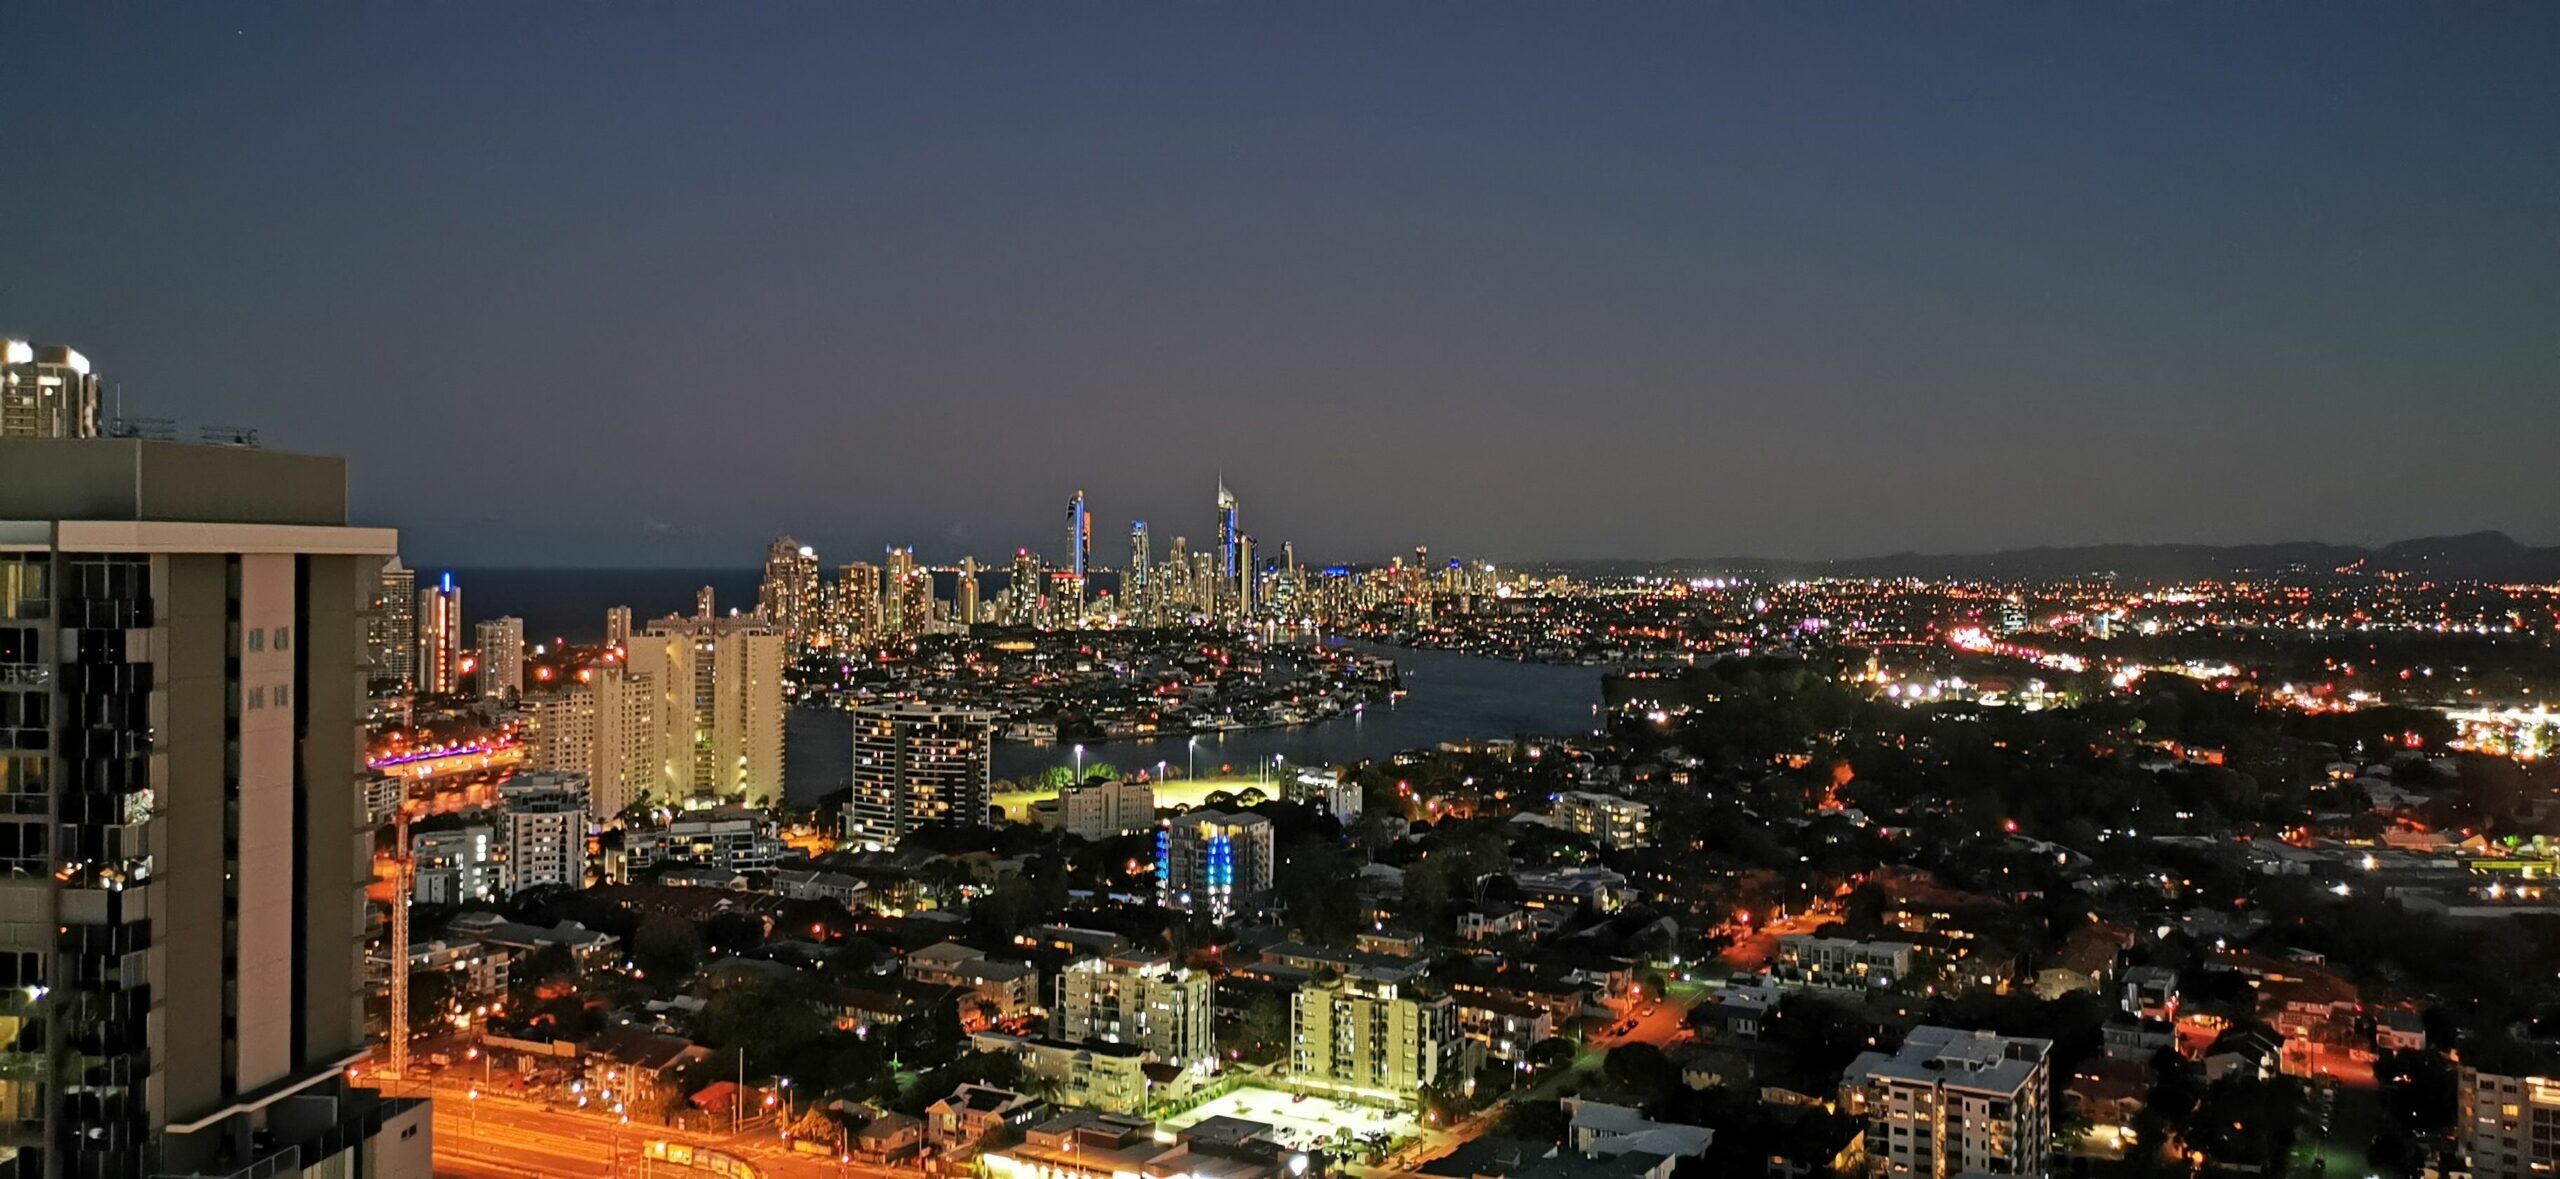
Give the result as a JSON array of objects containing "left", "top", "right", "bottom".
[{"left": 0, "top": 3, "right": 2560, "bottom": 565}]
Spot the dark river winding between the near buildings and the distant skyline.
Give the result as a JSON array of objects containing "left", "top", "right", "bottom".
[{"left": 783, "top": 642, "right": 1600, "bottom": 803}]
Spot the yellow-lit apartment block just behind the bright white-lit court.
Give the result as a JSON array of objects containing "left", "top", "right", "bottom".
[{"left": 1288, "top": 974, "right": 1467, "bottom": 1102}]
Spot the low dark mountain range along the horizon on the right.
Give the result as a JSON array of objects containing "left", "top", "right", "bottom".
[{"left": 1541, "top": 532, "right": 2560, "bottom": 583}]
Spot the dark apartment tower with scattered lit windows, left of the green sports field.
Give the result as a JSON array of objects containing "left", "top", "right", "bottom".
[{"left": 845, "top": 703, "right": 996, "bottom": 852}]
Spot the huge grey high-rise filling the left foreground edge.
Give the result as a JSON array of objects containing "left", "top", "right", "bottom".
[{"left": 0, "top": 437, "right": 430, "bottom": 1179}]
